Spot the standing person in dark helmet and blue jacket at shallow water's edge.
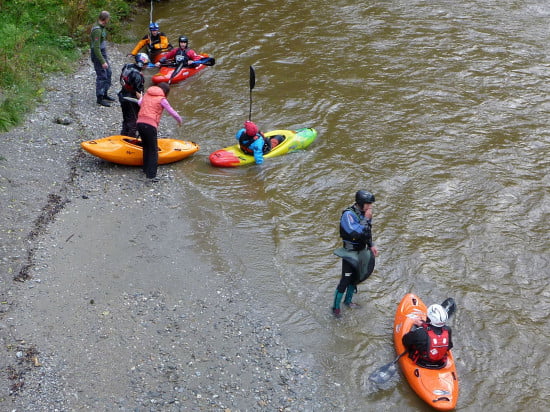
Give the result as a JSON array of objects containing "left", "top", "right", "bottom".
[{"left": 332, "top": 190, "right": 378, "bottom": 318}]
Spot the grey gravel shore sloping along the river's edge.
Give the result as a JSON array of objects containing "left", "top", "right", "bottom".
[{"left": 0, "top": 46, "right": 341, "bottom": 411}]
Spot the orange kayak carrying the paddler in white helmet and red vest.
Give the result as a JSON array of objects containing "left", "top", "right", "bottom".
[{"left": 393, "top": 293, "right": 458, "bottom": 411}]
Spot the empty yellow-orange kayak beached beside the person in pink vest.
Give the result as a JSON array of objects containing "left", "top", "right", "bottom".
[{"left": 80, "top": 135, "right": 200, "bottom": 166}]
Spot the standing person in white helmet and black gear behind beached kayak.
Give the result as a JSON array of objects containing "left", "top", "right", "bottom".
[{"left": 118, "top": 53, "right": 149, "bottom": 138}]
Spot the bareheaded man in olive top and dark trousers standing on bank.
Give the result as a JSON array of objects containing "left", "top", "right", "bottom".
[{"left": 90, "top": 10, "right": 115, "bottom": 107}]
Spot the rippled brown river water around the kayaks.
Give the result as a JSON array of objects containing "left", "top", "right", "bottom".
[{"left": 134, "top": 0, "right": 550, "bottom": 411}]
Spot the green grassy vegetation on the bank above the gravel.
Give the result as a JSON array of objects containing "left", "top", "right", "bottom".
[{"left": 0, "top": 0, "right": 143, "bottom": 131}]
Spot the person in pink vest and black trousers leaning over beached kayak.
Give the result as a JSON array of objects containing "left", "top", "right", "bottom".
[{"left": 137, "top": 83, "right": 182, "bottom": 182}]
